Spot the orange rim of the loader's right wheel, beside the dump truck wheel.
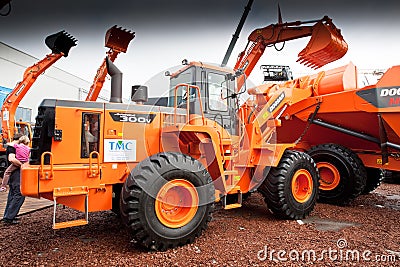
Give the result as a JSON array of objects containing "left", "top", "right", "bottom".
[{"left": 292, "top": 169, "right": 313, "bottom": 203}]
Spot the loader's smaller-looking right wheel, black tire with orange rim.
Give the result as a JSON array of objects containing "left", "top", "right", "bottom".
[{"left": 258, "top": 150, "right": 319, "bottom": 220}]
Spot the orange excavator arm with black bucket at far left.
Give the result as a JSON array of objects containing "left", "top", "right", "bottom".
[{"left": 1, "top": 31, "right": 76, "bottom": 142}]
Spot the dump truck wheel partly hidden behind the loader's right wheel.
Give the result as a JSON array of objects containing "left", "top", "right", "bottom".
[{"left": 308, "top": 144, "right": 367, "bottom": 206}]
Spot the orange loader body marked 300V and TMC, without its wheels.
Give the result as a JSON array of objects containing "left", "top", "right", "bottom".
[{"left": 21, "top": 62, "right": 311, "bottom": 217}]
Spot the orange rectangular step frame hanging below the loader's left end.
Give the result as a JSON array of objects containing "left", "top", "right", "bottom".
[{"left": 53, "top": 186, "right": 89, "bottom": 230}]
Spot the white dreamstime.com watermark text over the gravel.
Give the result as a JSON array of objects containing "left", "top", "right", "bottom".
[{"left": 257, "top": 238, "right": 396, "bottom": 263}]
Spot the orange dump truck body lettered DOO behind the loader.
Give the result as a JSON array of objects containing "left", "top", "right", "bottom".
[{"left": 264, "top": 63, "right": 400, "bottom": 171}]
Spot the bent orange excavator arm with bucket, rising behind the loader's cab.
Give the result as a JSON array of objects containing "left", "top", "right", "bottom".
[{"left": 234, "top": 16, "right": 348, "bottom": 90}]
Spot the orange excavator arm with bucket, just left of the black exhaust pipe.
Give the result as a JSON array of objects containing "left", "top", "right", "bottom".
[{"left": 86, "top": 25, "right": 135, "bottom": 101}]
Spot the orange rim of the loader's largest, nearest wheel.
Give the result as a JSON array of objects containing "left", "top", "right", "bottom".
[{"left": 155, "top": 179, "right": 199, "bottom": 228}]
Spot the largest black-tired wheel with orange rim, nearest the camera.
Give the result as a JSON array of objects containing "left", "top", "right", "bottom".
[{"left": 120, "top": 152, "right": 215, "bottom": 251}]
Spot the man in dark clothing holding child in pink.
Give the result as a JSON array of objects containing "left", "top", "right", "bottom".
[{"left": 3, "top": 134, "right": 25, "bottom": 224}]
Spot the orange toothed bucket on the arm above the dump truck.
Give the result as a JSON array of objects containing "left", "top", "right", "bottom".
[{"left": 297, "top": 21, "right": 348, "bottom": 69}]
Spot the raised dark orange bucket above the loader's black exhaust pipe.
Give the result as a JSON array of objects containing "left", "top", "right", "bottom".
[{"left": 105, "top": 25, "right": 135, "bottom": 53}]
